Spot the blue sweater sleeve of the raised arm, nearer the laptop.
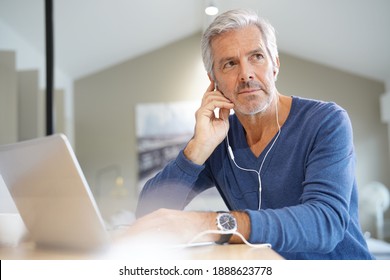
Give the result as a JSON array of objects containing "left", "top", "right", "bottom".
[{"left": 136, "top": 151, "right": 213, "bottom": 217}]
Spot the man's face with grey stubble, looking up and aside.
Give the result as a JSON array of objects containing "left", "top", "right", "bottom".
[{"left": 211, "top": 26, "right": 278, "bottom": 115}]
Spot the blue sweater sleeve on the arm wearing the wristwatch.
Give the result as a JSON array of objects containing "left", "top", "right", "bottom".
[{"left": 247, "top": 105, "right": 357, "bottom": 254}]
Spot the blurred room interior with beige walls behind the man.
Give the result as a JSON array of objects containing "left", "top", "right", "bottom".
[{"left": 0, "top": 0, "right": 390, "bottom": 247}]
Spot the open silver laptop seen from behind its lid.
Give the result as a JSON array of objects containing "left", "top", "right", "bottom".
[{"left": 0, "top": 134, "right": 110, "bottom": 250}]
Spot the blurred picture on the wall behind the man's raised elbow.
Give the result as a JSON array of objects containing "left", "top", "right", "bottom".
[{"left": 135, "top": 101, "right": 199, "bottom": 190}]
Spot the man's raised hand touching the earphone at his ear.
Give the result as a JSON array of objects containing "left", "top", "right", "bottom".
[{"left": 184, "top": 82, "right": 234, "bottom": 165}]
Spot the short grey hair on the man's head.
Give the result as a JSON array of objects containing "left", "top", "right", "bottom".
[{"left": 201, "top": 9, "right": 279, "bottom": 78}]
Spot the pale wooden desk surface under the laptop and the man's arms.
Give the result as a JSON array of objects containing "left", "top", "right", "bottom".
[{"left": 0, "top": 243, "right": 283, "bottom": 260}]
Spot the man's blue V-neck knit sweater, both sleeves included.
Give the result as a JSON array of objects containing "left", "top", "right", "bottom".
[{"left": 137, "top": 97, "right": 373, "bottom": 259}]
